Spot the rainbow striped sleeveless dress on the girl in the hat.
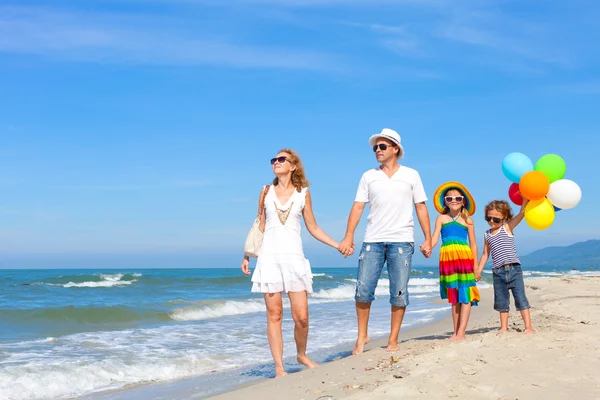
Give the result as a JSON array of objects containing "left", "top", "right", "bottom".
[{"left": 440, "top": 220, "right": 480, "bottom": 306}]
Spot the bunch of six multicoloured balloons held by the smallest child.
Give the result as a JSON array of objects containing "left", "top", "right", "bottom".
[{"left": 502, "top": 153, "right": 581, "bottom": 230}]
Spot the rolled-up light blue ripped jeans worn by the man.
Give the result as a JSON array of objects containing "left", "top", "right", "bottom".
[{"left": 354, "top": 242, "right": 415, "bottom": 307}]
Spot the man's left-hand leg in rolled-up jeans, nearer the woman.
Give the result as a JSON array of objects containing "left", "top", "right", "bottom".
[{"left": 352, "top": 243, "right": 385, "bottom": 355}]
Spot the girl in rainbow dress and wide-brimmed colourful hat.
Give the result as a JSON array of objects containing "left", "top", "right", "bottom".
[{"left": 432, "top": 182, "right": 480, "bottom": 341}]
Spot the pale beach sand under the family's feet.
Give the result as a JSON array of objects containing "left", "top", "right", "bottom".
[{"left": 211, "top": 277, "right": 600, "bottom": 400}]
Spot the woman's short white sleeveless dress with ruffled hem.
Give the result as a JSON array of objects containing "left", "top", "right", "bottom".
[{"left": 252, "top": 187, "right": 313, "bottom": 293}]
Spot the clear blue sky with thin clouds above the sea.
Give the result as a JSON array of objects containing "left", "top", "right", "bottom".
[{"left": 0, "top": 0, "right": 600, "bottom": 268}]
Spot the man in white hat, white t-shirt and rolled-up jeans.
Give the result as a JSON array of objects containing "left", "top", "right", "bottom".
[{"left": 338, "top": 128, "right": 431, "bottom": 354}]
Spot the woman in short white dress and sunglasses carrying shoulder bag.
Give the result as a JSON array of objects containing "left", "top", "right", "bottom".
[{"left": 242, "top": 149, "right": 346, "bottom": 378}]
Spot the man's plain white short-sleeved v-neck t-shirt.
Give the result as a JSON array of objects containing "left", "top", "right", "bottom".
[{"left": 354, "top": 165, "right": 427, "bottom": 243}]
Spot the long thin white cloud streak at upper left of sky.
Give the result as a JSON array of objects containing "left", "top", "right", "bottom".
[{"left": 0, "top": 7, "right": 336, "bottom": 70}]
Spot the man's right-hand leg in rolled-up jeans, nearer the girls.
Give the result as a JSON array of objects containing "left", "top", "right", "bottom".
[{"left": 386, "top": 242, "right": 415, "bottom": 351}]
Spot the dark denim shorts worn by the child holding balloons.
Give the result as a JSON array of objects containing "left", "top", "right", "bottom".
[{"left": 492, "top": 264, "right": 530, "bottom": 312}]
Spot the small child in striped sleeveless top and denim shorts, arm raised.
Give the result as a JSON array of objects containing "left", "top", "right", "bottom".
[{"left": 475, "top": 199, "right": 534, "bottom": 333}]
